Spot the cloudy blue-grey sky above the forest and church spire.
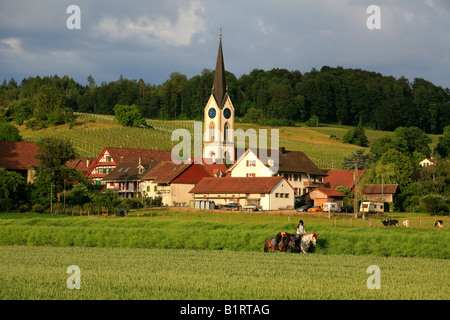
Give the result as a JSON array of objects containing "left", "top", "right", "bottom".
[{"left": 0, "top": 0, "right": 450, "bottom": 88}]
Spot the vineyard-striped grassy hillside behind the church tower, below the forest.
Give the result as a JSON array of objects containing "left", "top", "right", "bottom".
[{"left": 16, "top": 114, "right": 438, "bottom": 170}]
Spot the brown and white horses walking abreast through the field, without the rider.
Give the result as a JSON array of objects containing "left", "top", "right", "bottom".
[{"left": 264, "top": 232, "right": 317, "bottom": 254}]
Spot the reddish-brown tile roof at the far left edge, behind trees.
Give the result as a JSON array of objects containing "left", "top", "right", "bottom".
[{"left": 0, "top": 141, "right": 39, "bottom": 170}]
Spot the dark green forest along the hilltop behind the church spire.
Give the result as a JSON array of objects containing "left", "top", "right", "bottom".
[{"left": 0, "top": 66, "right": 450, "bottom": 133}]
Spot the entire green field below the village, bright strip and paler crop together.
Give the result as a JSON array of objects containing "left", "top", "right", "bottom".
[{"left": 0, "top": 211, "right": 450, "bottom": 300}]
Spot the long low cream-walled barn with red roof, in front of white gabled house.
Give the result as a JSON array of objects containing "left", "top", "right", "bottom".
[{"left": 190, "top": 177, "right": 295, "bottom": 210}]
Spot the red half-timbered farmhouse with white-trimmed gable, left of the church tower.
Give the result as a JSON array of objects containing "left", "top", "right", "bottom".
[{"left": 86, "top": 147, "right": 171, "bottom": 185}]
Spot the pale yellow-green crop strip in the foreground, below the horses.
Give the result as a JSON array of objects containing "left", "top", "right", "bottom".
[{"left": 0, "top": 246, "right": 450, "bottom": 300}]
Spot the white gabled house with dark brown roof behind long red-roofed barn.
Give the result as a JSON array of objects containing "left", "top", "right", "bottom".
[{"left": 228, "top": 148, "right": 326, "bottom": 196}]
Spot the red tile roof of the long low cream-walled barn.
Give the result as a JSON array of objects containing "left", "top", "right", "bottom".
[{"left": 190, "top": 177, "right": 288, "bottom": 194}]
